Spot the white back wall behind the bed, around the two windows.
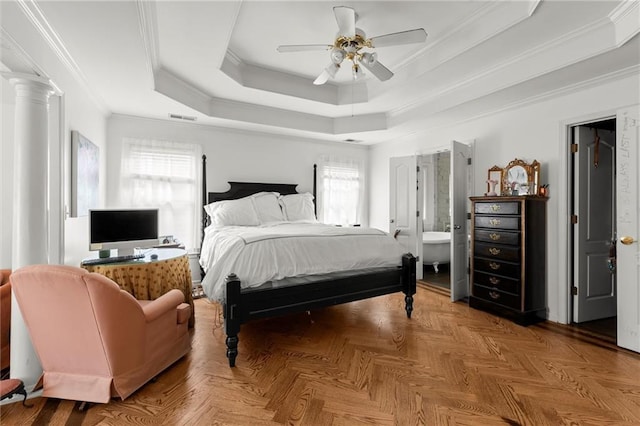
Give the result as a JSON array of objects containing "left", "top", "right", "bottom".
[{"left": 107, "top": 115, "right": 368, "bottom": 231}]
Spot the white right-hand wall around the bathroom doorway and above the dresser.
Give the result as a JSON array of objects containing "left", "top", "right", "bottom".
[{"left": 369, "top": 75, "right": 640, "bottom": 323}]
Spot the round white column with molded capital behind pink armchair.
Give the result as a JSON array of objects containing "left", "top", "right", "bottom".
[{"left": 5, "top": 74, "right": 53, "bottom": 391}]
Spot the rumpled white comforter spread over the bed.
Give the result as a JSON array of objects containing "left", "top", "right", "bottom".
[{"left": 200, "top": 222, "right": 403, "bottom": 301}]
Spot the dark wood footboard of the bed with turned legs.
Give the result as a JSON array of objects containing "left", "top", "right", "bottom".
[{"left": 224, "top": 253, "right": 416, "bottom": 367}]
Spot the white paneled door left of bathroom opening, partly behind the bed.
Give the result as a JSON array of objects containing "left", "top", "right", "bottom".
[{"left": 389, "top": 156, "right": 422, "bottom": 279}]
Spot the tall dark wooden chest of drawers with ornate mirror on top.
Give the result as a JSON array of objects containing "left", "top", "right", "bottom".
[{"left": 469, "top": 196, "right": 547, "bottom": 325}]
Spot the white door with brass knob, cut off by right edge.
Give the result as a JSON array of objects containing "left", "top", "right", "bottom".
[{"left": 616, "top": 105, "right": 640, "bottom": 352}]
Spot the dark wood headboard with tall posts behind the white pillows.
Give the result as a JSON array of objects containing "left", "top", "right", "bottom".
[{"left": 202, "top": 155, "right": 318, "bottom": 243}]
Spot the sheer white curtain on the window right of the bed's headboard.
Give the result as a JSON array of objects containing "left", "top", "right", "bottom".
[{"left": 318, "top": 156, "right": 365, "bottom": 226}]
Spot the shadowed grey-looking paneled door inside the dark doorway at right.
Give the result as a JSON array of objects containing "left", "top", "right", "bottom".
[{"left": 573, "top": 126, "right": 617, "bottom": 322}]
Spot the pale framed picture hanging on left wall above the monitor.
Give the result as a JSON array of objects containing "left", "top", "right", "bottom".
[{"left": 71, "top": 130, "right": 100, "bottom": 217}]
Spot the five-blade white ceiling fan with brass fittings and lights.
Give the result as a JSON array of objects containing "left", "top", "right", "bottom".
[{"left": 277, "top": 6, "right": 427, "bottom": 85}]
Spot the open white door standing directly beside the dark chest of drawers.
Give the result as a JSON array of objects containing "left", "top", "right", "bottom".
[{"left": 449, "top": 141, "right": 471, "bottom": 301}]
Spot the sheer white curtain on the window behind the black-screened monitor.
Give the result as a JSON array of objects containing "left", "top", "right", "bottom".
[{"left": 119, "top": 138, "right": 202, "bottom": 249}]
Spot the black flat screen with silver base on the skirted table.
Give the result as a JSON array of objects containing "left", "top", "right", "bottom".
[{"left": 89, "top": 209, "right": 158, "bottom": 256}]
